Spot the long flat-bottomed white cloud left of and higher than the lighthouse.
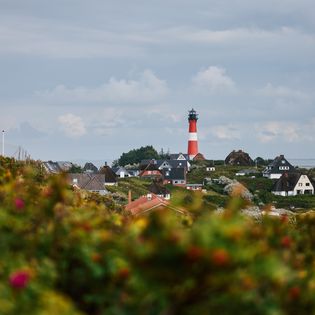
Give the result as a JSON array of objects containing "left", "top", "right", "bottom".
[{"left": 36, "top": 70, "right": 168, "bottom": 103}]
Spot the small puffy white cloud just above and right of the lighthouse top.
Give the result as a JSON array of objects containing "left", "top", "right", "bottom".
[{"left": 192, "top": 66, "right": 235, "bottom": 93}]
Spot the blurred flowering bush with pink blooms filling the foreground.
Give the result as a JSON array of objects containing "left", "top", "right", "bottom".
[{"left": 0, "top": 159, "right": 315, "bottom": 315}]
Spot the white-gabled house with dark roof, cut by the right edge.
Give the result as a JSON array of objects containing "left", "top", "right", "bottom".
[{"left": 272, "top": 173, "right": 314, "bottom": 196}]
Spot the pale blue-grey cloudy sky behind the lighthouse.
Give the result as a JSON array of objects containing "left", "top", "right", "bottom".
[{"left": 0, "top": 0, "right": 315, "bottom": 161}]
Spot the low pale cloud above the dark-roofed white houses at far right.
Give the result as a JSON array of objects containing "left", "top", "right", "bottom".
[{"left": 256, "top": 121, "right": 302, "bottom": 143}]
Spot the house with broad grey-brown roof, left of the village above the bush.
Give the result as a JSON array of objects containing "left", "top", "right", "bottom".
[{"left": 68, "top": 173, "right": 108, "bottom": 195}]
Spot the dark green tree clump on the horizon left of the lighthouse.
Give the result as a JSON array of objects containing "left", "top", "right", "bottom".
[{"left": 118, "top": 145, "right": 159, "bottom": 166}]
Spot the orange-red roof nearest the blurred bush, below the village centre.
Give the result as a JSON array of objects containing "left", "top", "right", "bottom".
[{"left": 125, "top": 193, "right": 187, "bottom": 216}]
